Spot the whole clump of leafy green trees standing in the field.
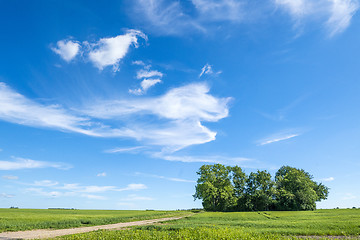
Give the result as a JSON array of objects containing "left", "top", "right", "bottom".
[{"left": 193, "top": 164, "right": 329, "bottom": 211}]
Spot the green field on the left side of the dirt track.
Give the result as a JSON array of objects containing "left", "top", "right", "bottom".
[{"left": 0, "top": 209, "right": 188, "bottom": 232}]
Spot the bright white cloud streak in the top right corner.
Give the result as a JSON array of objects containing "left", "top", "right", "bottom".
[{"left": 326, "top": 0, "right": 359, "bottom": 37}]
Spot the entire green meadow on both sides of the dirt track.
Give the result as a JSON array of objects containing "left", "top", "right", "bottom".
[{"left": 0, "top": 209, "right": 360, "bottom": 240}]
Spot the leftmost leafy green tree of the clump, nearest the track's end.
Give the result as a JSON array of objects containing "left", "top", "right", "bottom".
[{"left": 193, "top": 164, "right": 236, "bottom": 211}]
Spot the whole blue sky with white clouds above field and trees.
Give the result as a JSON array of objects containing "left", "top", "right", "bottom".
[{"left": 0, "top": 0, "right": 360, "bottom": 209}]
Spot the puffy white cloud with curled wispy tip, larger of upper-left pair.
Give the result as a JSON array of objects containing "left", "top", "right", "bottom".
[{"left": 88, "top": 30, "right": 147, "bottom": 72}]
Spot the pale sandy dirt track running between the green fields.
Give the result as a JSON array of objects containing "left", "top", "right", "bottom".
[{"left": 0, "top": 216, "right": 186, "bottom": 240}]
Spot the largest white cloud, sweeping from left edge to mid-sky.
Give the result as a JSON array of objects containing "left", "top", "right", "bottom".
[{"left": 0, "top": 83, "right": 230, "bottom": 151}]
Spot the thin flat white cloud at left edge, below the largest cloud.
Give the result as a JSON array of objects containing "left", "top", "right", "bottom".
[{"left": 0, "top": 157, "right": 71, "bottom": 170}]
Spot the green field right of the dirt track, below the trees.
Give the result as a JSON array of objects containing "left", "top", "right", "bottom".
[{"left": 54, "top": 209, "right": 360, "bottom": 240}]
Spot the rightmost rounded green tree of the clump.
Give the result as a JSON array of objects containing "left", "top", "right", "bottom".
[{"left": 275, "top": 166, "right": 329, "bottom": 210}]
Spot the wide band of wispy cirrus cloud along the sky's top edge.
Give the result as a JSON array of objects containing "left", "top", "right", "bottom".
[{"left": 131, "top": 0, "right": 359, "bottom": 37}]
